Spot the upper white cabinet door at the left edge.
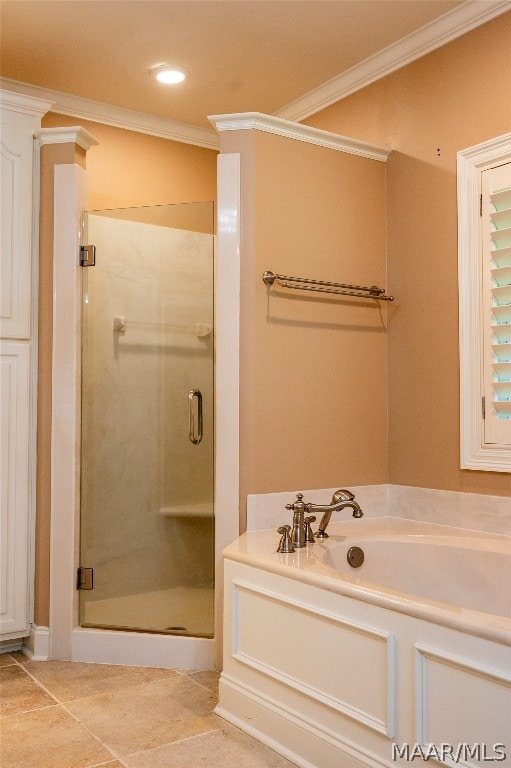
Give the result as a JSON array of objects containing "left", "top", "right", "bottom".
[{"left": 0, "top": 118, "right": 33, "bottom": 339}]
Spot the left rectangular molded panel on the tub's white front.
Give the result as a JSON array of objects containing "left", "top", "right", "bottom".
[{"left": 232, "top": 581, "right": 395, "bottom": 737}]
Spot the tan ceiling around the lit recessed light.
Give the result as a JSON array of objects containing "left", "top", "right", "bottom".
[{"left": 0, "top": 0, "right": 509, "bottom": 142}]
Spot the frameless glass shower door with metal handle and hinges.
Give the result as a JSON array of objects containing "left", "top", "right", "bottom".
[{"left": 79, "top": 203, "right": 214, "bottom": 637}]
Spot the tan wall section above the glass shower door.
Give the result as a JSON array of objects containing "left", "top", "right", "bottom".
[{"left": 42, "top": 113, "right": 218, "bottom": 210}]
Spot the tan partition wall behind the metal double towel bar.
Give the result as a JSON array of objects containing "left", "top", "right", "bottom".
[{"left": 222, "top": 131, "right": 387, "bottom": 524}]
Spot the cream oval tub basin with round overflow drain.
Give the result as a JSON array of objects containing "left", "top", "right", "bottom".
[{"left": 314, "top": 518, "right": 511, "bottom": 632}]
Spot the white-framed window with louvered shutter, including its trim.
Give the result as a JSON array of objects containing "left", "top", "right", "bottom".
[{"left": 458, "top": 134, "right": 511, "bottom": 472}]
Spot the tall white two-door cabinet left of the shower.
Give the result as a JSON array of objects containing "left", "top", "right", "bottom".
[{"left": 0, "top": 91, "right": 50, "bottom": 641}]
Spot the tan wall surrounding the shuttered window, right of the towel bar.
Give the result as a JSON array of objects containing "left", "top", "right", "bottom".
[{"left": 306, "top": 13, "right": 511, "bottom": 495}]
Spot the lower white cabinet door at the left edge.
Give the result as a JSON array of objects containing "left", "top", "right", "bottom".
[{"left": 0, "top": 341, "right": 30, "bottom": 639}]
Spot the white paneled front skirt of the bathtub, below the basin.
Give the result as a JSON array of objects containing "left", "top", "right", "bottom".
[{"left": 220, "top": 552, "right": 511, "bottom": 768}]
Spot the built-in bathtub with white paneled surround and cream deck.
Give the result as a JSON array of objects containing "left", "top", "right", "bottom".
[{"left": 217, "top": 517, "right": 511, "bottom": 768}]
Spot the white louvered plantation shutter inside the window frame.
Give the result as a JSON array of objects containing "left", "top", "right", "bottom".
[{"left": 481, "top": 163, "right": 511, "bottom": 447}]
